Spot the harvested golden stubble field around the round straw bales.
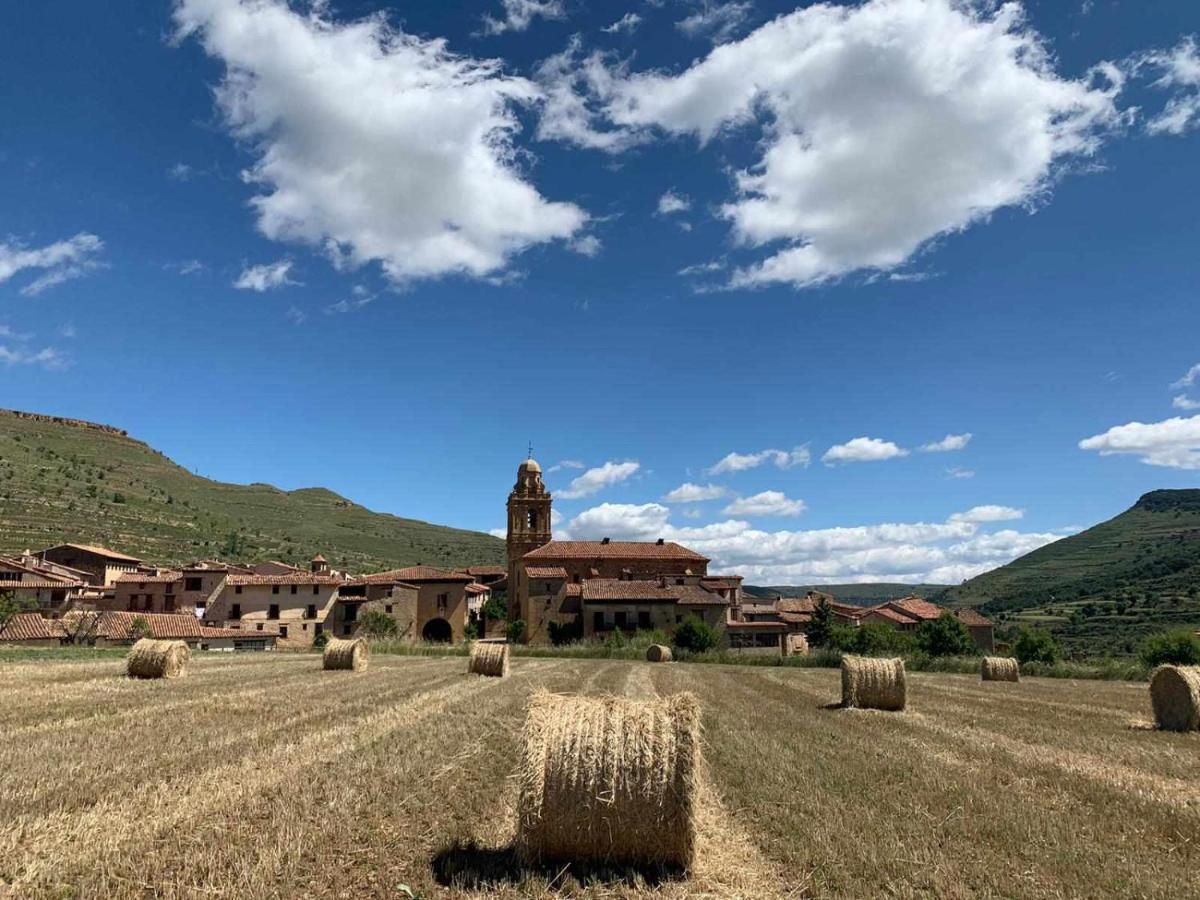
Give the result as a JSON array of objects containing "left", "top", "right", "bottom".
[{"left": 0, "top": 654, "right": 1200, "bottom": 898}]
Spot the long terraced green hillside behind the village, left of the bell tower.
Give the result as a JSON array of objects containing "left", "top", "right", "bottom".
[{"left": 0, "top": 410, "right": 504, "bottom": 571}]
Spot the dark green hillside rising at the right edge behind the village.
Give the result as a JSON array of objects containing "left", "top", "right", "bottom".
[{"left": 937, "top": 490, "right": 1200, "bottom": 653}]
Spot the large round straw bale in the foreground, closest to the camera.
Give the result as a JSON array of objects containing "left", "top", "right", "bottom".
[{"left": 517, "top": 691, "right": 701, "bottom": 869}]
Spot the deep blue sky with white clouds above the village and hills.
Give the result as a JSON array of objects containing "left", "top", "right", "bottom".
[{"left": 0, "top": 0, "right": 1200, "bottom": 583}]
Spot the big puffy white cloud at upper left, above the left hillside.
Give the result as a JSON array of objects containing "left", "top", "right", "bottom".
[{"left": 175, "top": 0, "right": 586, "bottom": 281}]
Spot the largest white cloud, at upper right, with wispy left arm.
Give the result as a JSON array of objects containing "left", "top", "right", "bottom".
[{"left": 557, "top": 0, "right": 1127, "bottom": 288}]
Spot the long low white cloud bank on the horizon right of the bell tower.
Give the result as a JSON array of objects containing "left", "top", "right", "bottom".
[{"left": 566, "top": 503, "right": 1064, "bottom": 584}]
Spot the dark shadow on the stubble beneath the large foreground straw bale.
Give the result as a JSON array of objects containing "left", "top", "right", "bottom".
[{"left": 430, "top": 840, "right": 686, "bottom": 890}]
